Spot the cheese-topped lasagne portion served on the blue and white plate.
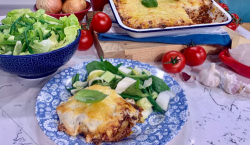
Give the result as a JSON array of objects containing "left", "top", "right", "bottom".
[{"left": 56, "top": 85, "right": 142, "bottom": 144}]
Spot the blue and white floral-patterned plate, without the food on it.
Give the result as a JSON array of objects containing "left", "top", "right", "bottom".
[{"left": 36, "top": 59, "right": 188, "bottom": 145}]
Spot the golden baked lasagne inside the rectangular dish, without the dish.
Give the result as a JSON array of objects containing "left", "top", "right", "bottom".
[{"left": 113, "top": 0, "right": 212, "bottom": 29}]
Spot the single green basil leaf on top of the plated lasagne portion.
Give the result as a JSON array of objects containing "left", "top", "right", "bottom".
[{"left": 75, "top": 89, "right": 108, "bottom": 103}]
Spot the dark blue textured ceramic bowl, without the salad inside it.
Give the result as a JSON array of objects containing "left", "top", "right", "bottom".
[{"left": 0, "top": 30, "right": 81, "bottom": 79}]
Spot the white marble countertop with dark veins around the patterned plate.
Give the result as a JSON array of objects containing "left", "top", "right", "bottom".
[{"left": 0, "top": 22, "right": 250, "bottom": 145}]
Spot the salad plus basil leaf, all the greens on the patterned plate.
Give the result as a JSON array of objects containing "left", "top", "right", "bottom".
[{"left": 65, "top": 58, "right": 176, "bottom": 119}]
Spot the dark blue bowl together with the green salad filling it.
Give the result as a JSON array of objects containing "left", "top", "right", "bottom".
[{"left": 0, "top": 9, "right": 81, "bottom": 78}]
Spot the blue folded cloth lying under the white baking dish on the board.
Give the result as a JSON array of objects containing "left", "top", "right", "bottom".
[{"left": 98, "top": 26, "right": 231, "bottom": 46}]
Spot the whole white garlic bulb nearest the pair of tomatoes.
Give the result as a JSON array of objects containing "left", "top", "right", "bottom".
[{"left": 199, "top": 63, "right": 221, "bottom": 87}]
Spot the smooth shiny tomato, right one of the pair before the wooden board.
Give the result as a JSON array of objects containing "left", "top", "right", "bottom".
[{"left": 183, "top": 46, "right": 207, "bottom": 66}]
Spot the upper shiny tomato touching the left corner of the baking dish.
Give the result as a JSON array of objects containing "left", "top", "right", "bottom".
[{"left": 91, "top": 12, "right": 112, "bottom": 33}]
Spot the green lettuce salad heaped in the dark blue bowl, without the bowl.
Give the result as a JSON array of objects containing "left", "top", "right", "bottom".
[{"left": 0, "top": 9, "right": 80, "bottom": 55}]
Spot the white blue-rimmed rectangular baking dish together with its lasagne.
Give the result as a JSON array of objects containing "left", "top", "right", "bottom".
[{"left": 109, "top": 0, "right": 232, "bottom": 38}]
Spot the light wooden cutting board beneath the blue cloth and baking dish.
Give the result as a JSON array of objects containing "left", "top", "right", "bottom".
[{"left": 87, "top": 12, "right": 241, "bottom": 62}]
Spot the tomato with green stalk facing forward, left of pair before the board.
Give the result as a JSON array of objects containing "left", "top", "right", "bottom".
[{"left": 162, "top": 51, "right": 186, "bottom": 73}]
